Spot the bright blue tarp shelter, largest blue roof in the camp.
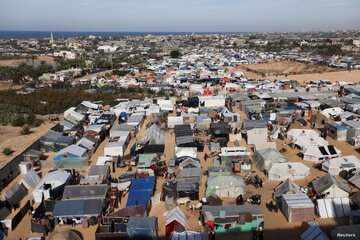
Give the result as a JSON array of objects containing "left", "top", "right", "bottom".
[{"left": 126, "top": 176, "right": 155, "bottom": 207}]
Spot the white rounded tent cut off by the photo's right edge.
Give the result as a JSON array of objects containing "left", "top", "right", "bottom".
[{"left": 321, "top": 155, "right": 360, "bottom": 175}]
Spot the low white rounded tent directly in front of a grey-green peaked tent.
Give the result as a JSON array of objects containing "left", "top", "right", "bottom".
[{"left": 268, "top": 162, "right": 310, "bottom": 181}]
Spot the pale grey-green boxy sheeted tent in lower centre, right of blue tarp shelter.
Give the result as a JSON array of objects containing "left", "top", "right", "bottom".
[{"left": 205, "top": 175, "right": 245, "bottom": 198}]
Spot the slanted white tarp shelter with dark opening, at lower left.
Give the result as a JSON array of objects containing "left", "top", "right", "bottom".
[{"left": 33, "top": 170, "right": 71, "bottom": 203}]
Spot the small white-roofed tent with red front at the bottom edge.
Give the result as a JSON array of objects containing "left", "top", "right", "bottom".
[{"left": 165, "top": 207, "right": 186, "bottom": 237}]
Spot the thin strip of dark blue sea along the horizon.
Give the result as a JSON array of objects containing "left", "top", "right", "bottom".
[{"left": 0, "top": 31, "right": 246, "bottom": 39}]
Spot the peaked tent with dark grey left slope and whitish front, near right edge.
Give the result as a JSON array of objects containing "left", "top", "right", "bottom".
[{"left": 312, "top": 173, "right": 351, "bottom": 198}]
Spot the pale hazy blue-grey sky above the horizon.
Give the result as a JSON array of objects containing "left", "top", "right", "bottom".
[{"left": 0, "top": 0, "right": 360, "bottom": 32}]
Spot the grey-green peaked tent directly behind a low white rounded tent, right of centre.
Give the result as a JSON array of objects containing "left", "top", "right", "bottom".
[{"left": 253, "top": 148, "right": 288, "bottom": 171}]
